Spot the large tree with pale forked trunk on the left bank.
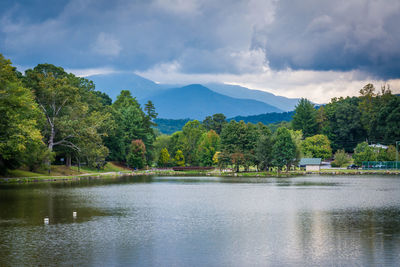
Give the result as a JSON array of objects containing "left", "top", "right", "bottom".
[{"left": 23, "top": 64, "right": 110, "bottom": 170}]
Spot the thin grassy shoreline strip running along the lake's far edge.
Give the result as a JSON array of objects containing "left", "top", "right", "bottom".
[{"left": 0, "top": 163, "right": 400, "bottom": 184}]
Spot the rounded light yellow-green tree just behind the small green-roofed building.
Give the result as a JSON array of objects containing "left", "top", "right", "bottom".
[{"left": 301, "top": 134, "right": 332, "bottom": 159}]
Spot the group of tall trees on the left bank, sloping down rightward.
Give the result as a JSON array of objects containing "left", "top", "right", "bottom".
[{"left": 0, "top": 54, "right": 157, "bottom": 174}]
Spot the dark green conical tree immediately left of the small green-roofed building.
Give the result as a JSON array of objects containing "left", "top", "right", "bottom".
[{"left": 272, "top": 128, "right": 296, "bottom": 173}]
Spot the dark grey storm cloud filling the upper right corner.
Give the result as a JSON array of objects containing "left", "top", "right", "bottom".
[{"left": 255, "top": 0, "right": 400, "bottom": 78}]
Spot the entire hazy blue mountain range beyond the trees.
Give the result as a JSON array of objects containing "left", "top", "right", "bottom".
[{"left": 86, "top": 73, "right": 299, "bottom": 120}]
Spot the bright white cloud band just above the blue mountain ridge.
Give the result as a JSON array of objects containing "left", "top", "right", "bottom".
[{"left": 136, "top": 62, "right": 400, "bottom": 103}]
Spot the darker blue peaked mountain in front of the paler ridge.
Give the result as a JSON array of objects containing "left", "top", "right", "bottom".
[{"left": 144, "top": 84, "right": 281, "bottom": 120}]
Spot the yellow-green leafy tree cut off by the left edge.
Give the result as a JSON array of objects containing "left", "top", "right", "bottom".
[{"left": 0, "top": 54, "right": 47, "bottom": 173}]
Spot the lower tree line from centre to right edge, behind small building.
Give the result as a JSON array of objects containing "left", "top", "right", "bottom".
[{"left": 154, "top": 84, "right": 400, "bottom": 171}]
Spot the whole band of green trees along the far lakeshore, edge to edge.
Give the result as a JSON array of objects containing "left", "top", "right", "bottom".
[{"left": 0, "top": 55, "right": 400, "bottom": 175}]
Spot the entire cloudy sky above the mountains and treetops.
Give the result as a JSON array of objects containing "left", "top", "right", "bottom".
[{"left": 0, "top": 0, "right": 400, "bottom": 103}]
